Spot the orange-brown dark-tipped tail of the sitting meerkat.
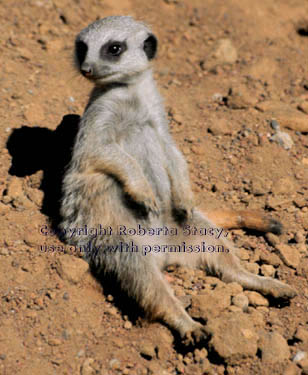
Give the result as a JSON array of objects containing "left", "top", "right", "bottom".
[{"left": 206, "top": 209, "right": 283, "bottom": 234}]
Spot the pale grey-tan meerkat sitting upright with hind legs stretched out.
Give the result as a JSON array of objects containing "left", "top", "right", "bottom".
[{"left": 61, "top": 16, "right": 296, "bottom": 343}]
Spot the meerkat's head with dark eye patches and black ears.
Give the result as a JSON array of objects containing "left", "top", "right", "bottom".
[{"left": 75, "top": 16, "right": 157, "bottom": 86}]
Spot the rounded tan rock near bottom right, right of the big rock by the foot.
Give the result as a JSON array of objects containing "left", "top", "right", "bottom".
[{"left": 259, "top": 332, "right": 290, "bottom": 363}]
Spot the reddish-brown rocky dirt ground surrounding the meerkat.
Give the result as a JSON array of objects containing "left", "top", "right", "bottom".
[{"left": 0, "top": 0, "right": 308, "bottom": 375}]
